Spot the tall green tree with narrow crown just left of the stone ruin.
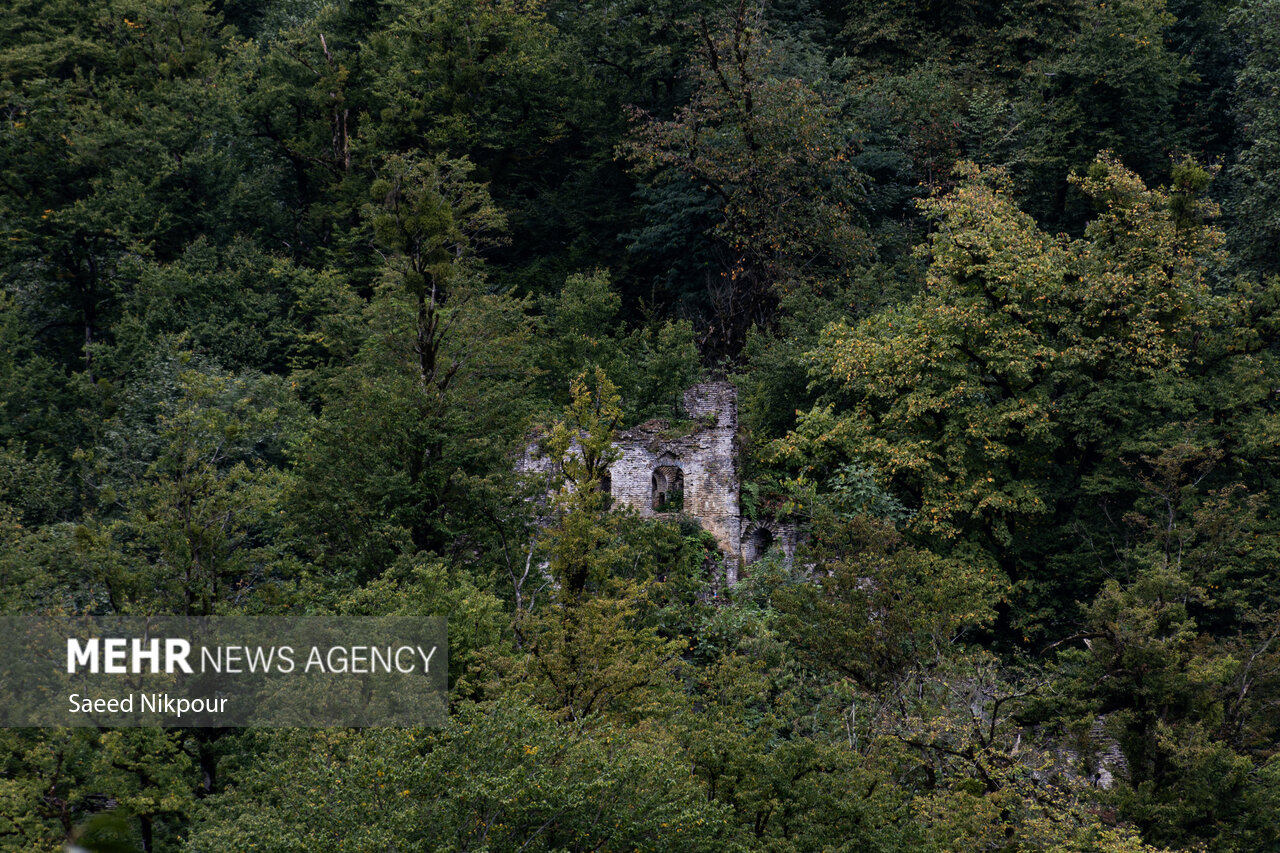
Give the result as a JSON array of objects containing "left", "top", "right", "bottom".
[{"left": 289, "top": 155, "right": 529, "bottom": 579}]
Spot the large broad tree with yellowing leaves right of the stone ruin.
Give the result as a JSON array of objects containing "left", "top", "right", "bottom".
[{"left": 774, "top": 158, "right": 1265, "bottom": 630}]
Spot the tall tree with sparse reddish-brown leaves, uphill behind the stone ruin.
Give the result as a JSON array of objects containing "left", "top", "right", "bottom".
[{"left": 621, "top": 1, "right": 867, "bottom": 356}]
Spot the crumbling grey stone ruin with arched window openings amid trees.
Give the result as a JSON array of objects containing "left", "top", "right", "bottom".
[{"left": 520, "top": 382, "right": 796, "bottom": 584}]
